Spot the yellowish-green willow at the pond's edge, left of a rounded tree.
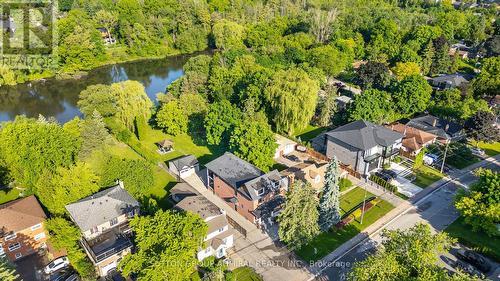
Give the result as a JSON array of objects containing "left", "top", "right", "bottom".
[{"left": 111, "top": 80, "right": 153, "bottom": 130}]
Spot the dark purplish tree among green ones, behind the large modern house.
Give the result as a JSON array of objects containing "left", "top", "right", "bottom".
[{"left": 357, "top": 61, "right": 391, "bottom": 89}]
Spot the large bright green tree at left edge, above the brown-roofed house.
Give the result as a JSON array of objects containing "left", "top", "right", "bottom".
[{"left": 0, "top": 116, "right": 79, "bottom": 189}]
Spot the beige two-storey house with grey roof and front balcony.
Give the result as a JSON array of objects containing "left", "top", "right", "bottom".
[{"left": 66, "top": 181, "right": 139, "bottom": 276}]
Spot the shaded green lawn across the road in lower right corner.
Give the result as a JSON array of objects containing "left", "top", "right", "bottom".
[{"left": 445, "top": 217, "right": 500, "bottom": 262}]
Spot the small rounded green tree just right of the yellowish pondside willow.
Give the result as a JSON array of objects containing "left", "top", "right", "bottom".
[{"left": 156, "top": 100, "right": 188, "bottom": 136}]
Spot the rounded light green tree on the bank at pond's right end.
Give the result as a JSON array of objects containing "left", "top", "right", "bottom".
[{"left": 212, "top": 19, "right": 245, "bottom": 50}]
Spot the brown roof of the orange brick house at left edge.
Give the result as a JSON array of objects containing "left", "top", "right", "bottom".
[{"left": 0, "top": 195, "right": 47, "bottom": 233}]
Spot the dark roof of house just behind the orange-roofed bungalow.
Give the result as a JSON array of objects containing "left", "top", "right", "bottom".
[{"left": 406, "top": 114, "right": 463, "bottom": 139}]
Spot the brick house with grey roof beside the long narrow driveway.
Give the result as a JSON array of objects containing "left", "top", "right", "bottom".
[{"left": 205, "top": 152, "right": 288, "bottom": 226}]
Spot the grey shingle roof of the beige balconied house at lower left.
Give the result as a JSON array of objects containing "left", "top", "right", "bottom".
[{"left": 66, "top": 184, "right": 139, "bottom": 231}]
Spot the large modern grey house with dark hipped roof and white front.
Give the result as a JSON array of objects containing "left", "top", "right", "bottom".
[{"left": 324, "top": 120, "right": 403, "bottom": 176}]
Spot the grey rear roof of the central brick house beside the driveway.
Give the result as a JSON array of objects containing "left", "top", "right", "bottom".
[{"left": 205, "top": 152, "right": 263, "bottom": 188}]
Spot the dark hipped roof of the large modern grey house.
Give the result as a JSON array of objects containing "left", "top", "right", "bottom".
[{"left": 326, "top": 120, "right": 403, "bottom": 150}]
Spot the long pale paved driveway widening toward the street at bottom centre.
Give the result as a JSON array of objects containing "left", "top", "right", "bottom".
[{"left": 185, "top": 171, "right": 314, "bottom": 281}]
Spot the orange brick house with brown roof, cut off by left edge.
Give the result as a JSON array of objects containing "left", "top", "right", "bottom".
[{"left": 0, "top": 195, "right": 47, "bottom": 261}]
